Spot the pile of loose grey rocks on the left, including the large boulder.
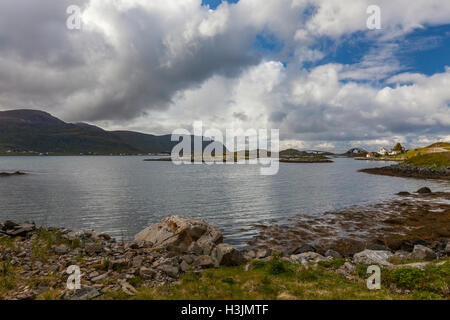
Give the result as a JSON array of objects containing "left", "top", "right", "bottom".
[{"left": 0, "top": 216, "right": 245, "bottom": 299}]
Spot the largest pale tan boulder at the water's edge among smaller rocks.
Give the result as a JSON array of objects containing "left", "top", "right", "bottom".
[{"left": 135, "top": 216, "right": 223, "bottom": 253}]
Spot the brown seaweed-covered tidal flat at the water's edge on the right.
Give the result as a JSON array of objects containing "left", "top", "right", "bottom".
[{"left": 249, "top": 188, "right": 450, "bottom": 257}]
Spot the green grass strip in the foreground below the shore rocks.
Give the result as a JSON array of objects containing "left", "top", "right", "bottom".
[{"left": 103, "top": 258, "right": 432, "bottom": 300}]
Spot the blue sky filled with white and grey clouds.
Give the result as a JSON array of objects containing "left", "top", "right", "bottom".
[{"left": 0, "top": 0, "right": 450, "bottom": 151}]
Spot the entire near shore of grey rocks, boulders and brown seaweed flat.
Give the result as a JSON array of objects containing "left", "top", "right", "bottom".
[{"left": 0, "top": 189, "right": 450, "bottom": 300}]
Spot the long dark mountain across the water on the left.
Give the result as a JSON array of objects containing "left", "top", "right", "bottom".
[{"left": 0, "top": 110, "right": 223, "bottom": 154}]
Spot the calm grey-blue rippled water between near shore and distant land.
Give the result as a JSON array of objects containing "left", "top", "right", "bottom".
[{"left": 0, "top": 157, "right": 450, "bottom": 245}]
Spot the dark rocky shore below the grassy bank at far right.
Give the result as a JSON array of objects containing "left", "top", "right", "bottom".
[{"left": 359, "top": 164, "right": 450, "bottom": 180}]
